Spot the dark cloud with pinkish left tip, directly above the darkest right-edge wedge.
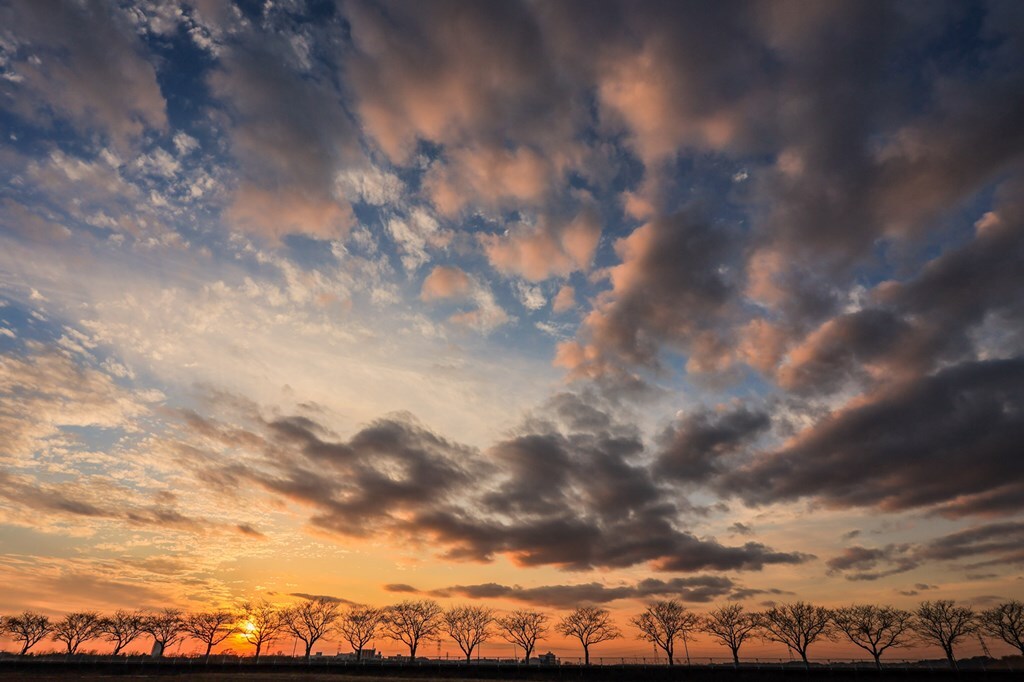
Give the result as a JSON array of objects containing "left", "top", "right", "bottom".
[{"left": 778, "top": 179, "right": 1024, "bottom": 392}]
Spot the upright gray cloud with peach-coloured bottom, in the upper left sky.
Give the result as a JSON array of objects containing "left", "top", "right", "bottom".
[{"left": 209, "top": 36, "right": 366, "bottom": 242}]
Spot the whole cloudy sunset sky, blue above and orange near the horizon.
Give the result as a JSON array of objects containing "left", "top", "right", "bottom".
[{"left": 0, "top": 0, "right": 1024, "bottom": 655}]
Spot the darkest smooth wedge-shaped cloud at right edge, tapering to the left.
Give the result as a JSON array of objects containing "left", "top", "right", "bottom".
[{"left": 716, "top": 359, "right": 1024, "bottom": 516}]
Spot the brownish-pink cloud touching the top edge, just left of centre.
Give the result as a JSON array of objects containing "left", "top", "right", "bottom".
[{"left": 345, "top": 2, "right": 575, "bottom": 163}]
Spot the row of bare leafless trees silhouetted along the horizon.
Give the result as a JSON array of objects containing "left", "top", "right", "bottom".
[{"left": 0, "top": 597, "right": 1024, "bottom": 669}]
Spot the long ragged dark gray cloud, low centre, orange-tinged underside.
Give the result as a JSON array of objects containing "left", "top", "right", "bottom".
[{"left": 182, "top": 394, "right": 810, "bottom": 572}]
